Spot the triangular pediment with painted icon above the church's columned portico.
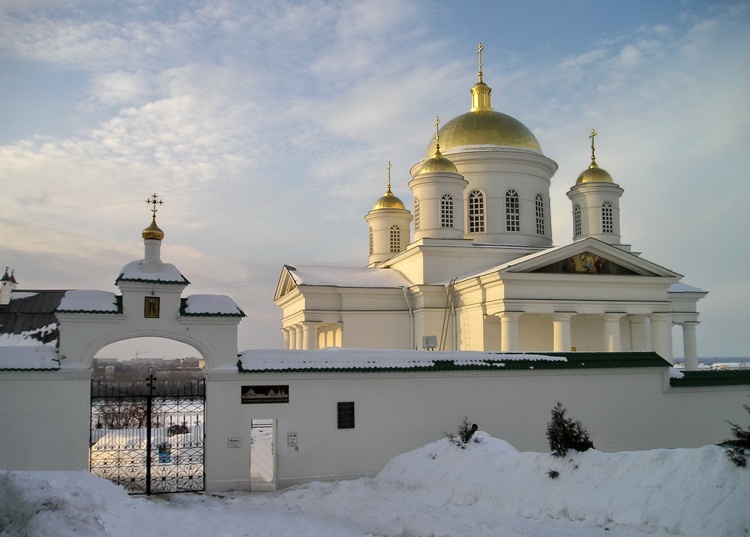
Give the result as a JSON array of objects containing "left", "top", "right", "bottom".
[{"left": 499, "top": 237, "right": 681, "bottom": 278}]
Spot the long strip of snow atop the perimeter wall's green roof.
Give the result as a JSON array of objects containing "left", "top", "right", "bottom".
[{"left": 240, "top": 348, "right": 567, "bottom": 371}]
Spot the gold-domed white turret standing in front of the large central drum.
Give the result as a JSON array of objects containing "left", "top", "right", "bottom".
[{"left": 409, "top": 118, "right": 469, "bottom": 241}]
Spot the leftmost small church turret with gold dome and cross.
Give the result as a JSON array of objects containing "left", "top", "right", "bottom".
[{"left": 365, "top": 162, "right": 412, "bottom": 266}]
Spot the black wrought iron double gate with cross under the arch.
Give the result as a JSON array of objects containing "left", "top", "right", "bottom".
[{"left": 90, "top": 375, "right": 206, "bottom": 494}]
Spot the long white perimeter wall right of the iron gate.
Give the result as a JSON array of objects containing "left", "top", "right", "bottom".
[{"left": 206, "top": 368, "right": 750, "bottom": 490}]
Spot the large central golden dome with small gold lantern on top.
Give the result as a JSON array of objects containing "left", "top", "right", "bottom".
[{"left": 425, "top": 79, "right": 542, "bottom": 157}]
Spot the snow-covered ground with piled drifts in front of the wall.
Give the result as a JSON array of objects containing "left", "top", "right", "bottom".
[{"left": 0, "top": 432, "right": 750, "bottom": 537}]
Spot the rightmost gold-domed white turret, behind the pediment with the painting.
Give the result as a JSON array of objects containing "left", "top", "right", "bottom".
[{"left": 568, "top": 130, "right": 623, "bottom": 246}]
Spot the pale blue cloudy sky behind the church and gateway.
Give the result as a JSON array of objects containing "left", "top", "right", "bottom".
[{"left": 0, "top": 0, "right": 750, "bottom": 356}]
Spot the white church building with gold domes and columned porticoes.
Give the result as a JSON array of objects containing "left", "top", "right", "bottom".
[{"left": 274, "top": 51, "right": 707, "bottom": 369}]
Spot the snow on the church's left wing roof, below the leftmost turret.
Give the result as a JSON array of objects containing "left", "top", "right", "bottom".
[{"left": 286, "top": 265, "right": 412, "bottom": 287}]
